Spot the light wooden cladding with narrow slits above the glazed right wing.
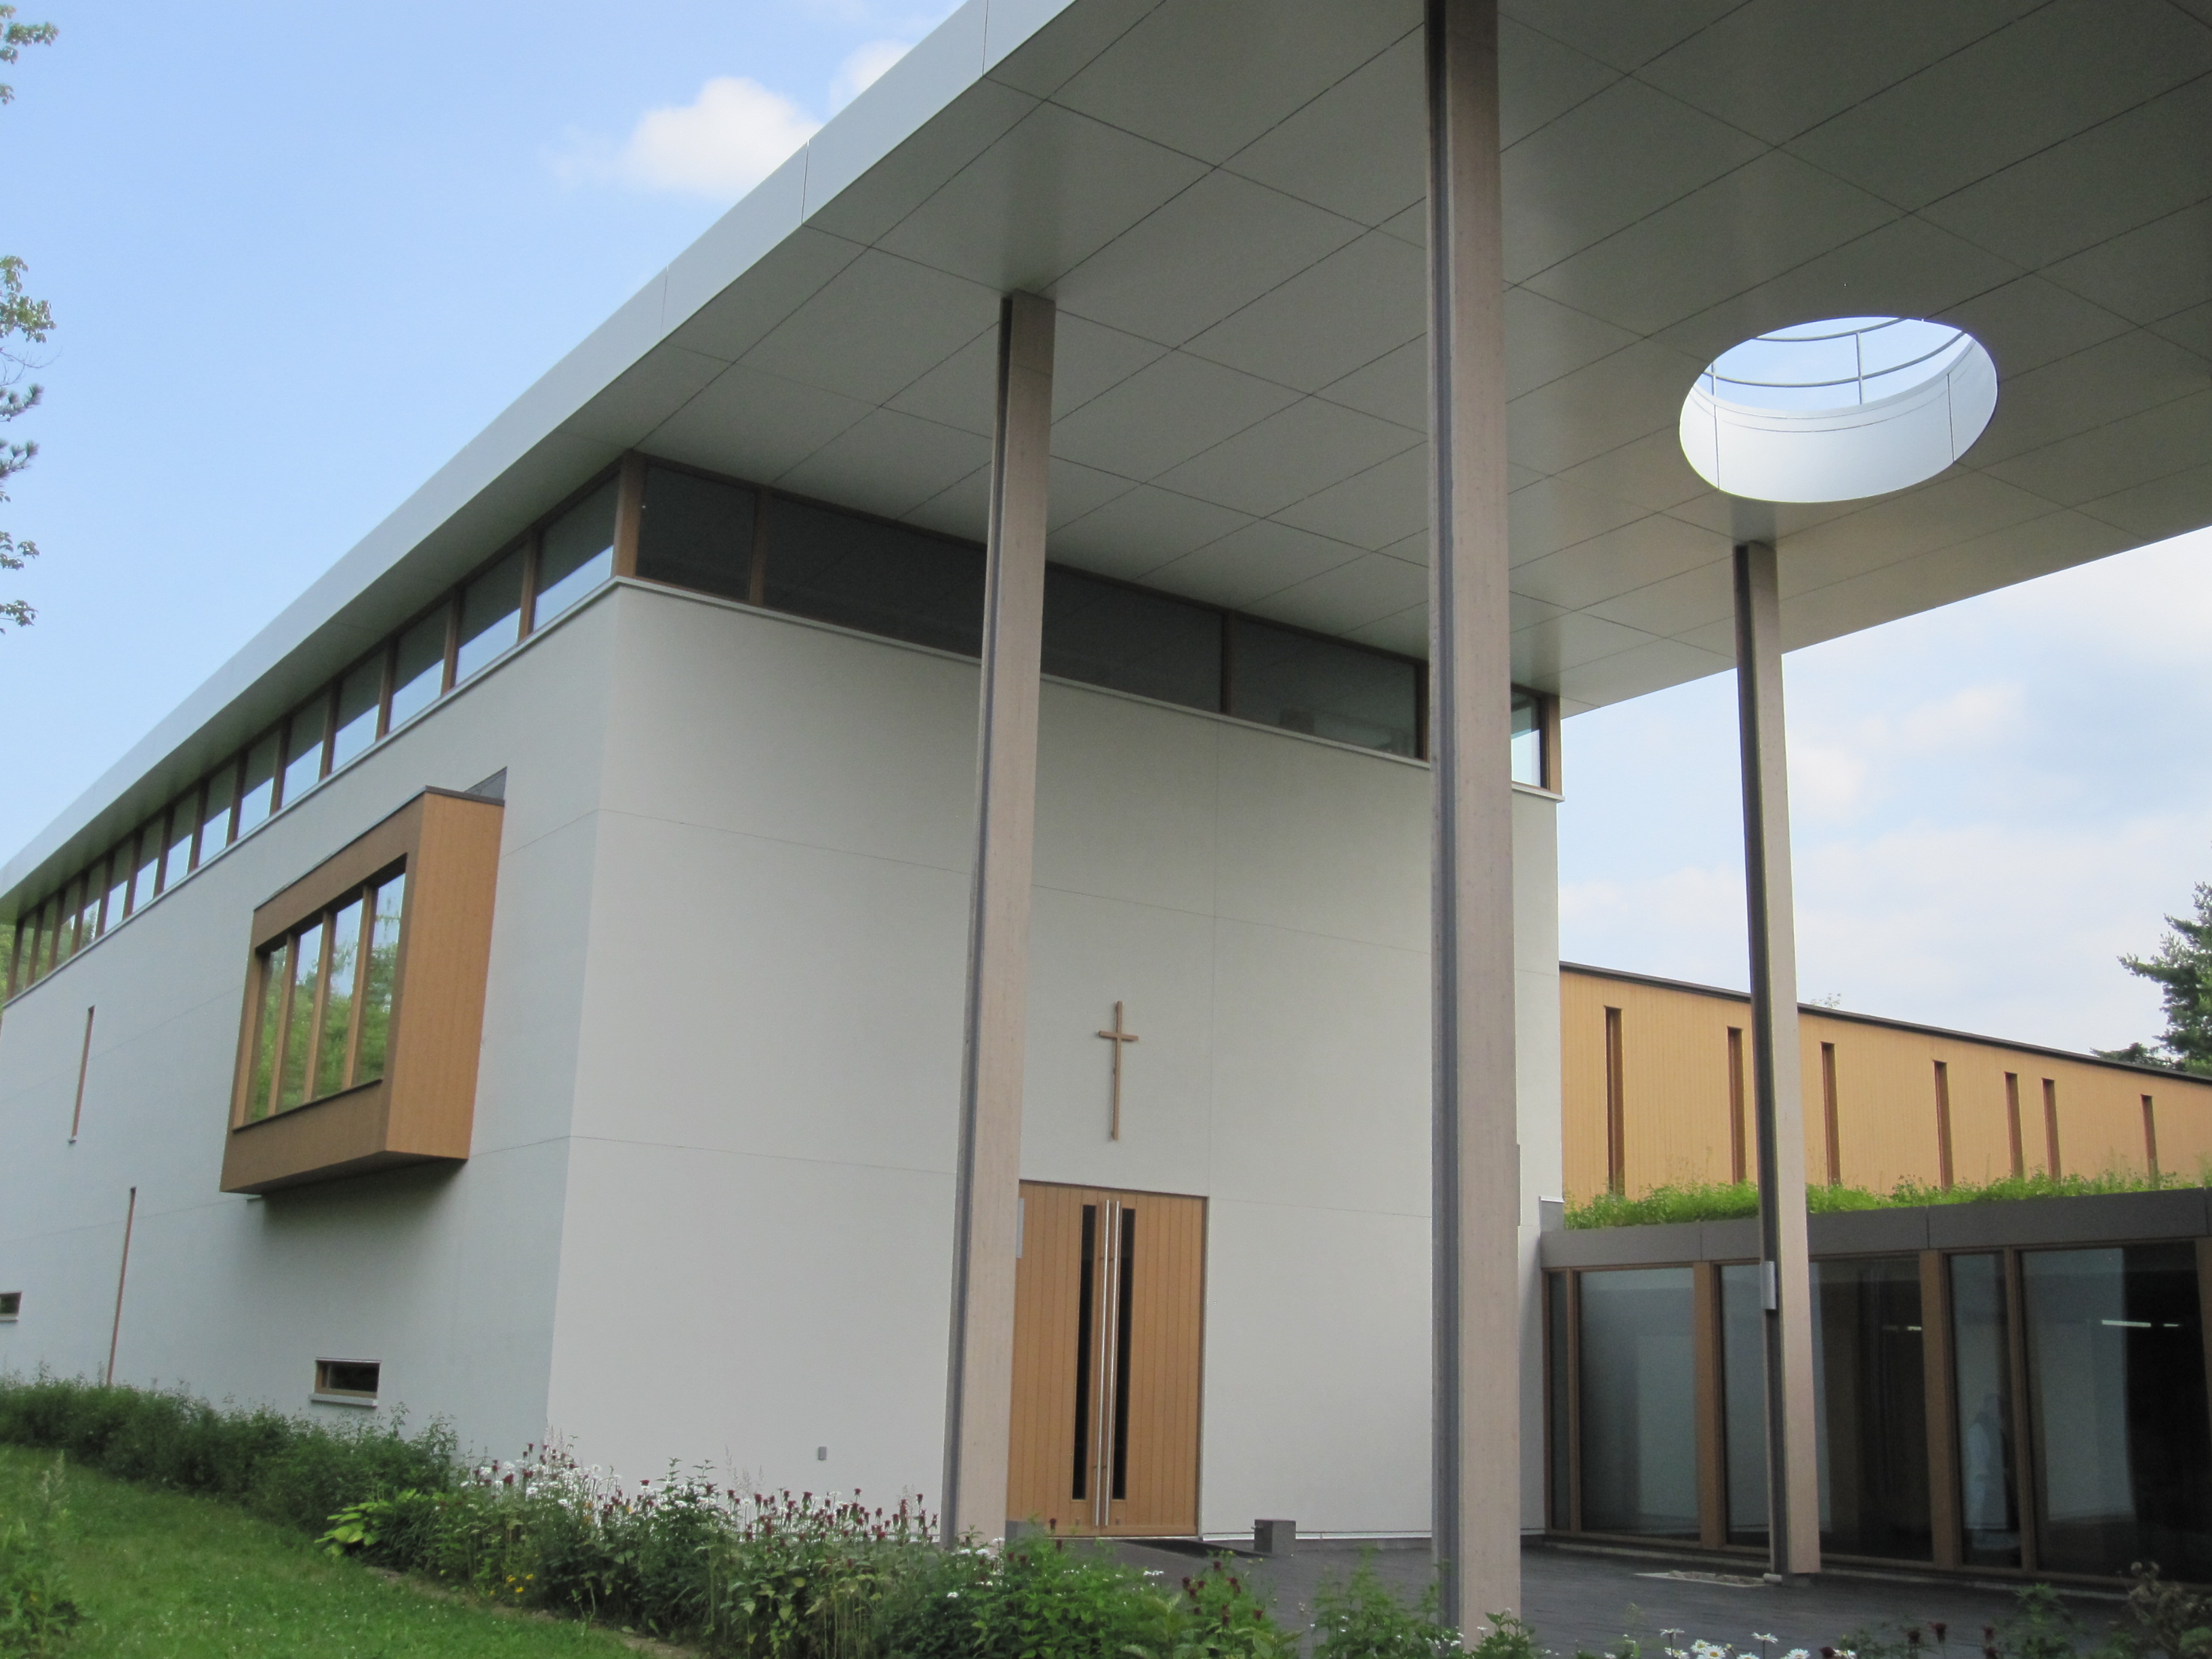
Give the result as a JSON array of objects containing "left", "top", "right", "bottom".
[{"left": 1559, "top": 966, "right": 2212, "bottom": 1201}]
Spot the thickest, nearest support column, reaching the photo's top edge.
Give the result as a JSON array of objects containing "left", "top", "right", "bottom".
[{"left": 1427, "top": 0, "right": 1519, "bottom": 1628}]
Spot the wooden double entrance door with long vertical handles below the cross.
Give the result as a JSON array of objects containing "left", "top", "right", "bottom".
[{"left": 1006, "top": 1181, "right": 1206, "bottom": 1537}]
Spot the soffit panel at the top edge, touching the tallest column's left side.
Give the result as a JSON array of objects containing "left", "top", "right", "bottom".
[{"left": 1053, "top": 0, "right": 1420, "bottom": 166}]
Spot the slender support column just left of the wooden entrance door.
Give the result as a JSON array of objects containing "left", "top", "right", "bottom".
[{"left": 942, "top": 294, "right": 1055, "bottom": 1544}]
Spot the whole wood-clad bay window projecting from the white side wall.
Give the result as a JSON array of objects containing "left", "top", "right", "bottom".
[{"left": 224, "top": 790, "right": 500, "bottom": 1192}]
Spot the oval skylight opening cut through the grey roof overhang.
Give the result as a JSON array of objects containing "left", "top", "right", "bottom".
[{"left": 1681, "top": 316, "right": 1997, "bottom": 502}]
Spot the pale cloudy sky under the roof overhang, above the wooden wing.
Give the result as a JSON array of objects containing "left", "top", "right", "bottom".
[{"left": 1559, "top": 533, "right": 2212, "bottom": 1048}]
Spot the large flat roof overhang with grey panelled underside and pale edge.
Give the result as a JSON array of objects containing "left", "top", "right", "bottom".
[{"left": 0, "top": 0, "right": 2212, "bottom": 914}]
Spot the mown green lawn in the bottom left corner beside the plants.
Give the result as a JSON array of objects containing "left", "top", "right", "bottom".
[{"left": 0, "top": 1447, "right": 633, "bottom": 1659}]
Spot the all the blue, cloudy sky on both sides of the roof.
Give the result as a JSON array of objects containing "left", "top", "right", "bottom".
[{"left": 0, "top": 0, "right": 2212, "bottom": 1046}]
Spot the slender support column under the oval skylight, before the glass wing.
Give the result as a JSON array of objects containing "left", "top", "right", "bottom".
[{"left": 1736, "top": 542, "right": 1820, "bottom": 1577}]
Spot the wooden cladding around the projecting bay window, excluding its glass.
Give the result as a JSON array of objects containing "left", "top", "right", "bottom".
[{"left": 224, "top": 790, "right": 502, "bottom": 1192}]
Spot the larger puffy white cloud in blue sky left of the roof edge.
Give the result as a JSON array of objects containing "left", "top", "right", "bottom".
[{"left": 553, "top": 70, "right": 823, "bottom": 201}]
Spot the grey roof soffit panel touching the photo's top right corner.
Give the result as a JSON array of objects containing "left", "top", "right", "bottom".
[{"left": 1790, "top": 0, "right": 2212, "bottom": 208}]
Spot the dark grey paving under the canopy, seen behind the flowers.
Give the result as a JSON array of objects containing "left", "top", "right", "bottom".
[{"left": 1120, "top": 1540, "right": 2121, "bottom": 1659}]
